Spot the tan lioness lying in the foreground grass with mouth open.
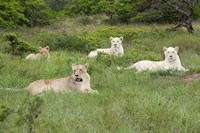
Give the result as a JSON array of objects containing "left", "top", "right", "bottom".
[{"left": 27, "top": 63, "right": 98, "bottom": 95}]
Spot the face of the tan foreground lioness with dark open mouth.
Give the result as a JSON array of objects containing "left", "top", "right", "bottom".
[{"left": 72, "top": 63, "right": 89, "bottom": 82}]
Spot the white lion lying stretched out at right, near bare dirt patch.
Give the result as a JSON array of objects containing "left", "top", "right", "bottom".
[{"left": 125, "top": 47, "right": 189, "bottom": 72}]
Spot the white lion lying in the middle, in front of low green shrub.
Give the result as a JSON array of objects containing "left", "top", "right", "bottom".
[{"left": 88, "top": 37, "right": 124, "bottom": 58}]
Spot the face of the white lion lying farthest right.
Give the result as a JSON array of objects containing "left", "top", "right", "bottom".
[{"left": 163, "top": 47, "right": 179, "bottom": 62}]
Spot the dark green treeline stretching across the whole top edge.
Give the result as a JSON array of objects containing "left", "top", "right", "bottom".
[{"left": 0, "top": 0, "right": 200, "bottom": 32}]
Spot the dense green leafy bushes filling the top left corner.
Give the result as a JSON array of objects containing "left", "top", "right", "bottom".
[{"left": 0, "top": 0, "right": 55, "bottom": 28}]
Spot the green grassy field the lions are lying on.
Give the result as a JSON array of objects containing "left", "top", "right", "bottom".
[{"left": 0, "top": 19, "right": 200, "bottom": 133}]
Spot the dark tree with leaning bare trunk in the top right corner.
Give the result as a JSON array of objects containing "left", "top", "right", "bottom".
[{"left": 132, "top": 0, "right": 198, "bottom": 33}]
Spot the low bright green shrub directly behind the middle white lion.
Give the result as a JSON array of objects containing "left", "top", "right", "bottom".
[{"left": 79, "top": 26, "right": 148, "bottom": 52}]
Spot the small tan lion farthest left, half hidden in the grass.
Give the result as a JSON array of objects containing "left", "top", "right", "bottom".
[{"left": 25, "top": 46, "right": 50, "bottom": 60}]
